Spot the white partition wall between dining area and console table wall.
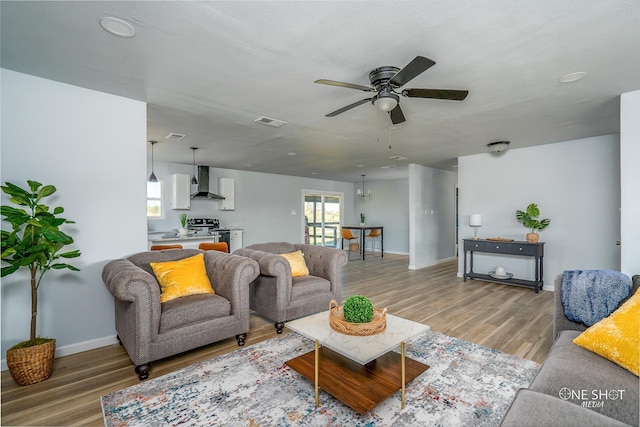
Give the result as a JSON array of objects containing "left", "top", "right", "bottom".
[{"left": 409, "top": 164, "right": 457, "bottom": 269}]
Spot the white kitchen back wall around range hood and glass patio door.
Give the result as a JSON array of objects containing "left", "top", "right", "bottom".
[{"left": 148, "top": 162, "right": 355, "bottom": 246}]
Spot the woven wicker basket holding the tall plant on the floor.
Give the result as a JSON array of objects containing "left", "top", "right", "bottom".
[{"left": 7, "top": 339, "right": 56, "bottom": 385}]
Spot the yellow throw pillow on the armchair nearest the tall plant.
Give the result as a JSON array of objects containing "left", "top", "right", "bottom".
[{"left": 149, "top": 254, "right": 215, "bottom": 303}]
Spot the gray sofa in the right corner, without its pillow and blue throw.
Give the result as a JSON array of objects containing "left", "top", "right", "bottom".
[{"left": 501, "top": 275, "right": 640, "bottom": 427}]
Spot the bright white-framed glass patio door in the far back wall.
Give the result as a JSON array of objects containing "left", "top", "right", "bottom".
[{"left": 303, "top": 190, "right": 344, "bottom": 248}]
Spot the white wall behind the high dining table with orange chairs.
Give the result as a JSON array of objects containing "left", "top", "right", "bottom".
[{"left": 356, "top": 179, "right": 409, "bottom": 255}]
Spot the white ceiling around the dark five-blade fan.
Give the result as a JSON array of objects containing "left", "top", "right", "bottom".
[{"left": 0, "top": 0, "right": 640, "bottom": 182}]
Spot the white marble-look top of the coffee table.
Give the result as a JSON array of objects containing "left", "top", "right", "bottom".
[{"left": 286, "top": 310, "right": 430, "bottom": 365}]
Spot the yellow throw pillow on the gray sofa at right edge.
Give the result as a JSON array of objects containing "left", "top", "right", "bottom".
[{"left": 573, "top": 289, "right": 640, "bottom": 375}]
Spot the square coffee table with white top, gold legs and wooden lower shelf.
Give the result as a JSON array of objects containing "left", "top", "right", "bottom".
[{"left": 285, "top": 311, "right": 429, "bottom": 414}]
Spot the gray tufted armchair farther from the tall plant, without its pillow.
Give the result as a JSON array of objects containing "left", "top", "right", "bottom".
[{"left": 234, "top": 242, "right": 347, "bottom": 334}]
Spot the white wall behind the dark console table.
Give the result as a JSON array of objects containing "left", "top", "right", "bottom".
[{"left": 458, "top": 135, "right": 620, "bottom": 289}]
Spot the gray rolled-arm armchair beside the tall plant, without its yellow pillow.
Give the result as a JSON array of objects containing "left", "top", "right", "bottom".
[{"left": 102, "top": 249, "right": 260, "bottom": 380}]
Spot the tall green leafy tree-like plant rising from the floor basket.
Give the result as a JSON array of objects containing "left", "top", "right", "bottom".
[{"left": 0, "top": 181, "right": 80, "bottom": 347}]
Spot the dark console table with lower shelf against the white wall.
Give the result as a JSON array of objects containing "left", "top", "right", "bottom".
[{"left": 463, "top": 239, "right": 544, "bottom": 293}]
